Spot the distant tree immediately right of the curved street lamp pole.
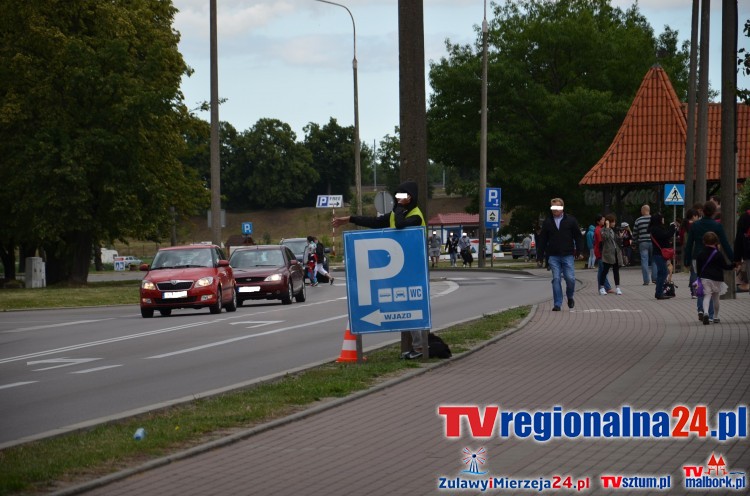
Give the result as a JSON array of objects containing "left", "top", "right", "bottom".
[{"left": 304, "top": 118, "right": 362, "bottom": 205}]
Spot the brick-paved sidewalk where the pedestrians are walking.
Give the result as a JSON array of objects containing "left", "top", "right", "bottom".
[{"left": 60, "top": 268, "right": 750, "bottom": 496}]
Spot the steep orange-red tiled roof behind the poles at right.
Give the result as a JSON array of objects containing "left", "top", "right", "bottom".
[{"left": 578, "top": 66, "right": 750, "bottom": 186}]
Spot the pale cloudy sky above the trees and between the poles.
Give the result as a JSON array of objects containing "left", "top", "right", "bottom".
[{"left": 173, "top": 0, "right": 750, "bottom": 146}]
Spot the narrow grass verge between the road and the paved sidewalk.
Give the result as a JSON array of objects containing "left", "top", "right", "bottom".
[{"left": 0, "top": 307, "right": 530, "bottom": 495}]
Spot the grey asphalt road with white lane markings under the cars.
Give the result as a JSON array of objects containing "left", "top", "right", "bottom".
[{"left": 0, "top": 270, "right": 551, "bottom": 448}]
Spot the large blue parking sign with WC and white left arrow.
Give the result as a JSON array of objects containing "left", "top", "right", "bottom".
[{"left": 344, "top": 227, "right": 432, "bottom": 334}]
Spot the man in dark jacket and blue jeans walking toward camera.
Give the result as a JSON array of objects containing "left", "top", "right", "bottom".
[{"left": 536, "top": 198, "right": 583, "bottom": 312}]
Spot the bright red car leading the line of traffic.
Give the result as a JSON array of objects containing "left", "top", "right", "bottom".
[{"left": 141, "top": 245, "right": 237, "bottom": 318}]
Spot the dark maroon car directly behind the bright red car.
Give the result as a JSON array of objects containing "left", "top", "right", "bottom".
[{"left": 229, "top": 245, "right": 307, "bottom": 306}]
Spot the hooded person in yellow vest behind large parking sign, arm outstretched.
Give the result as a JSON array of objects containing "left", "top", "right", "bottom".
[{"left": 332, "top": 181, "right": 427, "bottom": 358}]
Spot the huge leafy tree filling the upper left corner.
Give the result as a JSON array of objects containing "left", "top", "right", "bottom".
[{"left": 0, "top": 0, "right": 207, "bottom": 284}]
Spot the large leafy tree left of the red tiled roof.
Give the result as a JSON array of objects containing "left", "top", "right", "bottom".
[{"left": 428, "top": 0, "right": 688, "bottom": 219}]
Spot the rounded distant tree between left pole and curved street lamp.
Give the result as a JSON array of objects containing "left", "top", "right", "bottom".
[{"left": 222, "top": 119, "right": 320, "bottom": 210}]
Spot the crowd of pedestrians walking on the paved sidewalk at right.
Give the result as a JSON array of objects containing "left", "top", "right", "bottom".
[{"left": 537, "top": 198, "right": 750, "bottom": 325}]
